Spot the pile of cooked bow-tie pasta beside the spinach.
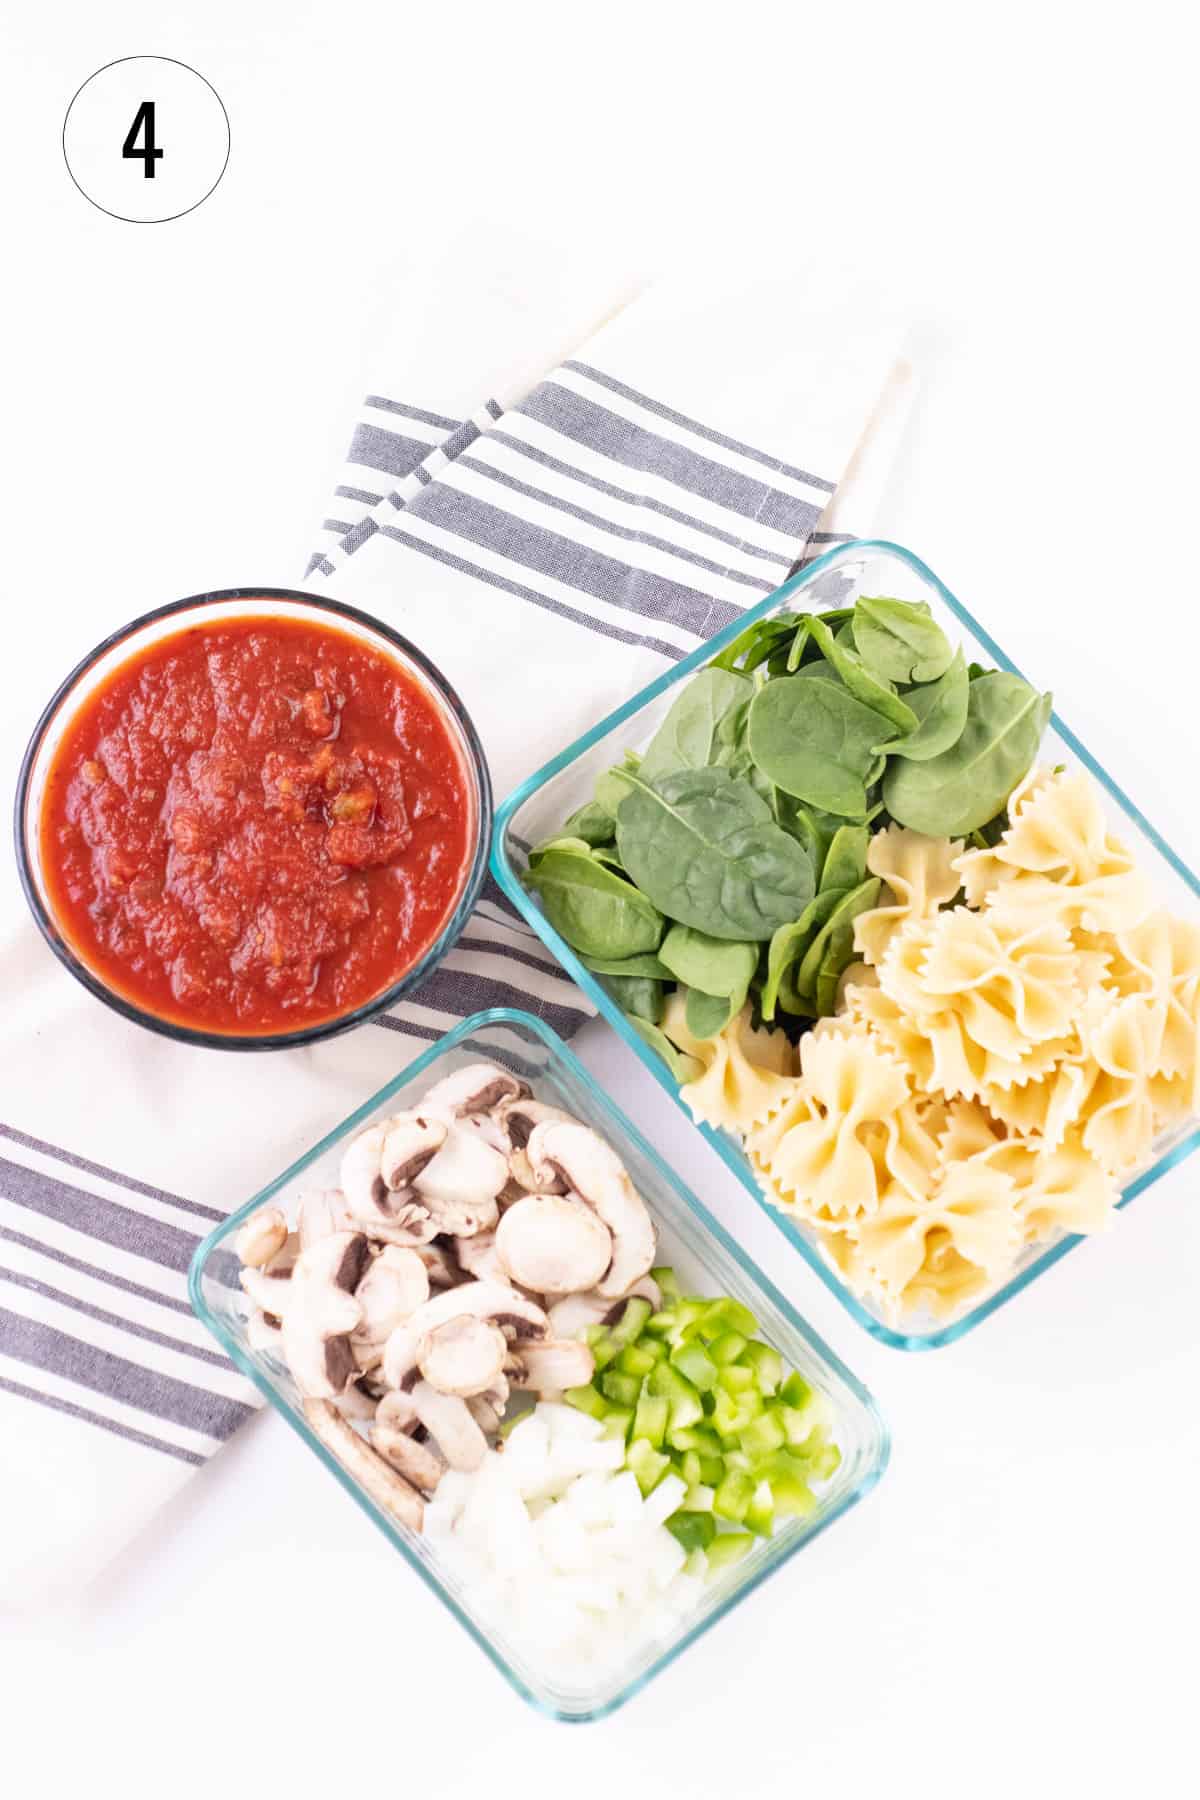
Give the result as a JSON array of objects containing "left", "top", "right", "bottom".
[{"left": 680, "top": 769, "right": 1200, "bottom": 1318}]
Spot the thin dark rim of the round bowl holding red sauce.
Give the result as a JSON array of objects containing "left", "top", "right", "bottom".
[{"left": 13, "top": 586, "right": 495, "bottom": 1051}]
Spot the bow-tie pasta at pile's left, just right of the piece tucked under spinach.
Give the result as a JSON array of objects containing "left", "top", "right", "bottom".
[{"left": 747, "top": 1031, "right": 909, "bottom": 1220}]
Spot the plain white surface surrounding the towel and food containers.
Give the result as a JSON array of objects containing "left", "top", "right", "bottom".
[{"left": 0, "top": 0, "right": 1200, "bottom": 1800}]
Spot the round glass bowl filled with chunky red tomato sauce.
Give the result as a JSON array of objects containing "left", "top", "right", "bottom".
[{"left": 16, "top": 587, "right": 491, "bottom": 1049}]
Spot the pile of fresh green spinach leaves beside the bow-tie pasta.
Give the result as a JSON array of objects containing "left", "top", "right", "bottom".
[{"left": 525, "top": 598, "right": 1051, "bottom": 1058}]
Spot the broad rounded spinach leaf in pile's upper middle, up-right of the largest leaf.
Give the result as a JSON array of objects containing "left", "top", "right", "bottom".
[{"left": 750, "top": 675, "right": 891, "bottom": 819}]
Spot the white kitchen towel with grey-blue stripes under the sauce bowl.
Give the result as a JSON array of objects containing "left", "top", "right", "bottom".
[{"left": 0, "top": 232, "right": 907, "bottom": 1600}]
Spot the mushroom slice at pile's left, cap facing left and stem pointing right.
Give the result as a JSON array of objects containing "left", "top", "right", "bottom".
[{"left": 282, "top": 1231, "right": 369, "bottom": 1400}]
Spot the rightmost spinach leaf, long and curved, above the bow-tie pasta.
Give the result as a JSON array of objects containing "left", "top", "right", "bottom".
[{"left": 883, "top": 670, "right": 1052, "bottom": 837}]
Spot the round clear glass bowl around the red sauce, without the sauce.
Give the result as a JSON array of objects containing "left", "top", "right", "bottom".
[{"left": 14, "top": 587, "right": 491, "bottom": 1049}]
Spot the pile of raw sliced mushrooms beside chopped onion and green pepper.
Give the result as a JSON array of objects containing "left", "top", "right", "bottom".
[{"left": 237, "top": 1062, "right": 660, "bottom": 1530}]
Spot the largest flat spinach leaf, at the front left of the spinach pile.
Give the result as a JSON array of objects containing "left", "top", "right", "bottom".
[{"left": 617, "top": 766, "right": 813, "bottom": 949}]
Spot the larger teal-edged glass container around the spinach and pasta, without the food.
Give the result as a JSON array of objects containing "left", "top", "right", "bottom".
[{"left": 491, "top": 538, "right": 1200, "bottom": 1350}]
